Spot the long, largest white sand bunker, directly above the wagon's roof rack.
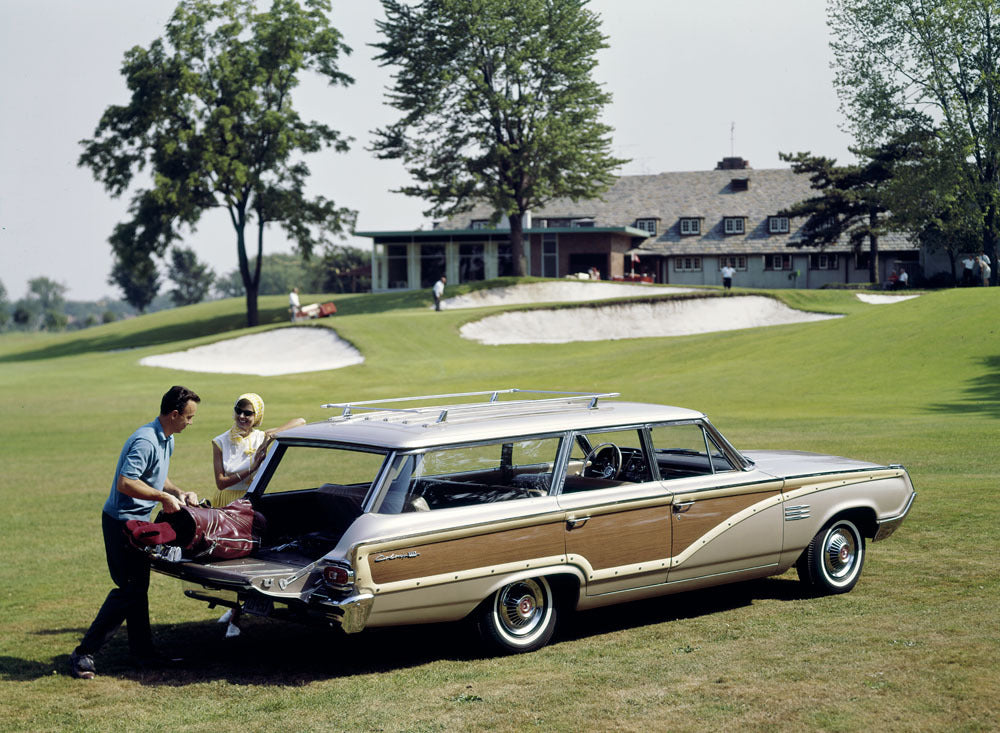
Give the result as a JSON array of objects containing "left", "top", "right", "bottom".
[{"left": 461, "top": 295, "right": 841, "bottom": 344}]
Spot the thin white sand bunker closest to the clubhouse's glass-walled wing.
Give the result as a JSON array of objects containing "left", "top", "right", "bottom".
[{"left": 441, "top": 280, "right": 693, "bottom": 308}]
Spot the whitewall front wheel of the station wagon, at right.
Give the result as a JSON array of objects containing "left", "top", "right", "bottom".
[{"left": 797, "top": 519, "right": 865, "bottom": 594}]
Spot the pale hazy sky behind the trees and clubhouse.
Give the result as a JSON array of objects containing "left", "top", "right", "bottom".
[{"left": 0, "top": 0, "right": 851, "bottom": 300}]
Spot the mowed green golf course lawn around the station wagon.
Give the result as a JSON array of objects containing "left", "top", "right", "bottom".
[{"left": 0, "top": 289, "right": 1000, "bottom": 733}]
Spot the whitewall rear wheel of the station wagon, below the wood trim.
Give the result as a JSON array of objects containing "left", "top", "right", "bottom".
[{"left": 478, "top": 578, "right": 556, "bottom": 654}]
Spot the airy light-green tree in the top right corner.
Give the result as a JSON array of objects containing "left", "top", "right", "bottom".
[{"left": 828, "top": 0, "right": 1000, "bottom": 279}]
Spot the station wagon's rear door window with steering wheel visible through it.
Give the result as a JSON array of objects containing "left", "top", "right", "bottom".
[{"left": 562, "top": 428, "right": 653, "bottom": 493}]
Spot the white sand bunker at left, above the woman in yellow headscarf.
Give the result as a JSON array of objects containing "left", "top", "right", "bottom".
[{"left": 139, "top": 326, "right": 365, "bottom": 377}]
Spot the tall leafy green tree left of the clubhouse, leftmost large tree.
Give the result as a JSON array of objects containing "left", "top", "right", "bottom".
[{"left": 79, "top": 0, "right": 354, "bottom": 325}]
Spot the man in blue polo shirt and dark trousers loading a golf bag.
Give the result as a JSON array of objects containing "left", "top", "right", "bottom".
[{"left": 70, "top": 386, "right": 201, "bottom": 679}]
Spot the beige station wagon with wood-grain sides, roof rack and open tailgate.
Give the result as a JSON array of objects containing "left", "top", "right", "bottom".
[{"left": 153, "top": 389, "right": 915, "bottom": 652}]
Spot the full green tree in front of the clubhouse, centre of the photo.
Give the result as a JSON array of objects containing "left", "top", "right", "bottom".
[{"left": 373, "top": 0, "right": 627, "bottom": 275}]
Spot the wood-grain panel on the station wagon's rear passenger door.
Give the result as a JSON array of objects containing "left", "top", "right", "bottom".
[{"left": 566, "top": 504, "right": 670, "bottom": 570}]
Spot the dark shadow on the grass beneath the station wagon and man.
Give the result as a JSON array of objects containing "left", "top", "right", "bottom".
[{"left": 17, "top": 578, "right": 810, "bottom": 687}]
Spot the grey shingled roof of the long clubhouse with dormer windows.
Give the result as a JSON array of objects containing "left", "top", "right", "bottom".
[{"left": 440, "top": 168, "right": 915, "bottom": 256}]
